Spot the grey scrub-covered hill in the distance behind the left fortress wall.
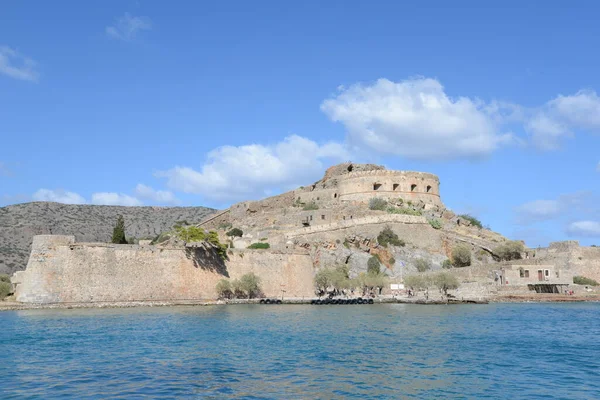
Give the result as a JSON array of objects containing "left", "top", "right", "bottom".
[{"left": 0, "top": 202, "right": 215, "bottom": 274}]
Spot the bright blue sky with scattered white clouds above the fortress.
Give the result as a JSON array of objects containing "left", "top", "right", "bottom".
[{"left": 0, "top": 1, "right": 600, "bottom": 246}]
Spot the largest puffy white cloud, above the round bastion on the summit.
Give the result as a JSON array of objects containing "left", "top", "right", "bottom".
[{"left": 321, "top": 78, "right": 512, "bottom": 159}]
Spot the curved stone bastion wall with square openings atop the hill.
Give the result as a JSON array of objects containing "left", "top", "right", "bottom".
[{"left": 338, "top": 171, "right": 443, "bottom": 206}]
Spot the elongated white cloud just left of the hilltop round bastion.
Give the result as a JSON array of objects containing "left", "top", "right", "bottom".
[{"left": 156, "top": 135, "right": 350, "bottom": 201}]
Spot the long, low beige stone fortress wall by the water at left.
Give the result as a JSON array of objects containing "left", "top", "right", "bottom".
[{"left": 16, "top": 236, "right": 313, "bottom": 303}]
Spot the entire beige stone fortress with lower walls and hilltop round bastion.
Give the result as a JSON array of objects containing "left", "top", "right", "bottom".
[{"left": 13, "top": 163, "right": 600, "bottom": 303}]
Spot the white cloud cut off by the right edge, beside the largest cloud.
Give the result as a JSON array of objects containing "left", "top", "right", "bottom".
[{"left": 525, "top": 90, "right": 600, "bottom": 150}]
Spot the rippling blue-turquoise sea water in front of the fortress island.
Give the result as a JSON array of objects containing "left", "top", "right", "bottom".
[{"left": 0, "top": 303, "right": 600, "bottom": 399}]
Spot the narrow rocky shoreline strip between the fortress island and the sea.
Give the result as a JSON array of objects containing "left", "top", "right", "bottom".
[{"left": 0, "top": 295, "right": 600, "bottom": 312}]
